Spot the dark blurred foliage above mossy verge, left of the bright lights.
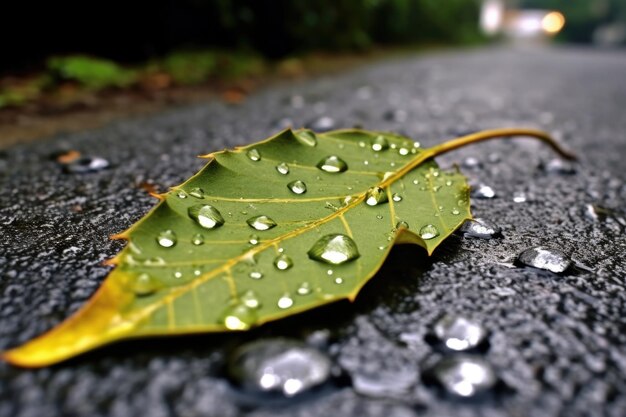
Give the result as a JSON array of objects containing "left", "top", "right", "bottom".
[{"left": 0, "top": 0, "right": 479, "bottom": 71}]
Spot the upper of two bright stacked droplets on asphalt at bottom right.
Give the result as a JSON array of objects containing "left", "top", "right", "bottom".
[{"left": 433, "top": 315, "right": 487, "bottom": 351}]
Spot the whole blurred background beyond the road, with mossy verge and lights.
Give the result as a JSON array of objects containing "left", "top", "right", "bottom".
[{"left": 0, "top": 0, "right": 626, "bottom": 143}]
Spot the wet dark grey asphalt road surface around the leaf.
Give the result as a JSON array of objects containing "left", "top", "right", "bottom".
[{"left": 0, "top": 49, "right": 626, "bottom": 417}]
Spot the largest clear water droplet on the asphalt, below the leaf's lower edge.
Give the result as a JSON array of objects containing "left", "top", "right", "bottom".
[{"left": 228, "top": 339, "right": 331, "bottom": 397}]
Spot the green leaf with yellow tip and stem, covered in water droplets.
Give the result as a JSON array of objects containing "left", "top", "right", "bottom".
[{"left": 4, "top": 126, "right": 567, "bottom": 366}]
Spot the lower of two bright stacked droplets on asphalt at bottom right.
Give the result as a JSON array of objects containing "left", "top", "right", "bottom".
[{"left": 433, "top": 355, "right": 497, "bottom": 397}]
